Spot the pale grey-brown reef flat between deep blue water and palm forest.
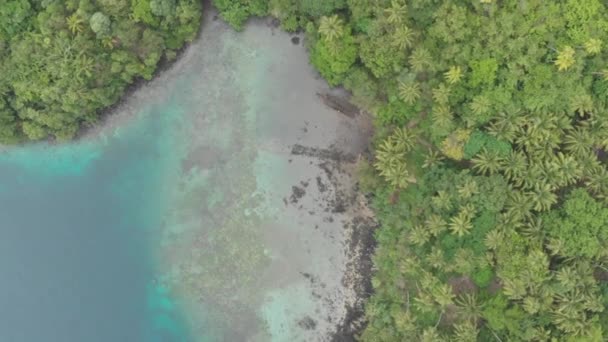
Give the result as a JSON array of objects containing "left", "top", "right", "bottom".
[{"left": 61, "top": 5, "right": 376, "bottom": 342}]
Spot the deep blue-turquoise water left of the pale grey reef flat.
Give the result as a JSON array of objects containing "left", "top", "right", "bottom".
[{"left": 0, "top": 104, "right": 189, "bottom": 342}]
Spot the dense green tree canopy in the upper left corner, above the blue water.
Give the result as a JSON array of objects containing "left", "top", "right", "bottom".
[{"left": 0, "top": 0, "right": 201, "bottom": 144}]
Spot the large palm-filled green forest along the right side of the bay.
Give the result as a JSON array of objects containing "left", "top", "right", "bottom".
[{"left": 218, "top": 0, "right": 608, "bottom": 342}]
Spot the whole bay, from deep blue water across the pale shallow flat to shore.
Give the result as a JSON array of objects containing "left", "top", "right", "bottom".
[{"left": 0, "top": 10, "right": 368, "bottom": 341}]
